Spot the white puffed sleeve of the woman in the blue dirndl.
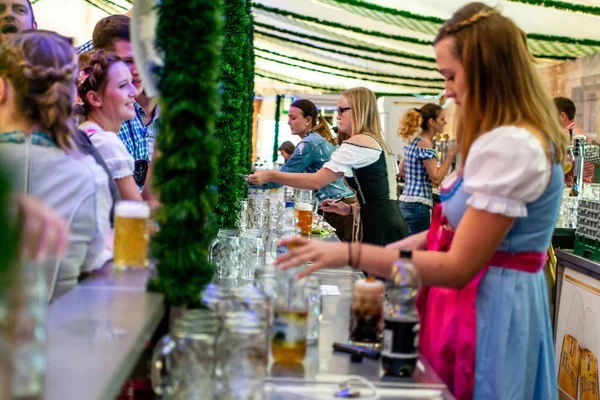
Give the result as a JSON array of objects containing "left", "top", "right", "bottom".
[{"left": 464, "top": 126, "right": 552, "bottom": 218}]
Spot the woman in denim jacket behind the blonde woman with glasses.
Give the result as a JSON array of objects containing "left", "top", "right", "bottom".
[{"left": 250, "top": 100, "right": 356, "bottom": 241}]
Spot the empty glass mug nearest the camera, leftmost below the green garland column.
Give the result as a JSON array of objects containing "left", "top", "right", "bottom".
[{"left": 151, "top": 310, "right": 219, "bottom": 400}]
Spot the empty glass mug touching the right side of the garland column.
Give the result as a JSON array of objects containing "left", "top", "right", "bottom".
[{"left": 208, "top": 229, "right": 242, "bottom": 279}]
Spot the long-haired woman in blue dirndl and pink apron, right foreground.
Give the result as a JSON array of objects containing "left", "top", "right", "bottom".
[{"left": 277, "top": 3, "right": 564, "bottom": 400}]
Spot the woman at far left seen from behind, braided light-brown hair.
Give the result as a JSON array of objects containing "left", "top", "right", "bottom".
[{"left": 0, "top": 30, "right": 111, "bottom": 294}]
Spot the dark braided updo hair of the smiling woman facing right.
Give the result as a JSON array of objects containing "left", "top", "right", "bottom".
[{"left": 75, "top": 50, "right": 121, "bottom": 116}]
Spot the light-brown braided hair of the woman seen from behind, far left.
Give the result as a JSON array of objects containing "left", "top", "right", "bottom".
[{"left": 0, "top": 30, "right": 77, "bottom": 150}]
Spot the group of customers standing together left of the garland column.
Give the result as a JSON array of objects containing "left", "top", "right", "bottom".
[{"left": 0, "top": 0, "right": 160, "bottom": 295}]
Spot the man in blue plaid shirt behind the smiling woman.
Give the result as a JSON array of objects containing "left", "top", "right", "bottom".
[{"left": 76, "top": 15, "right": 160, "bottom": 189}]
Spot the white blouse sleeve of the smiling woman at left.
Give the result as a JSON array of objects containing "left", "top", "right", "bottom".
[{"left": 90, "top": 132, "right": 134, "bottom": 179}]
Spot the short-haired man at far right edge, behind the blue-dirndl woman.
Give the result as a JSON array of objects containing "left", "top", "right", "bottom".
[{"left": 554, "top": 97, "right": 600, "bottom": 187}]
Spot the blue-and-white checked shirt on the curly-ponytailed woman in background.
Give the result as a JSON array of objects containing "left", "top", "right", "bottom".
[{"left": 400, "top": 136, "right": 437, "bottom": 207}]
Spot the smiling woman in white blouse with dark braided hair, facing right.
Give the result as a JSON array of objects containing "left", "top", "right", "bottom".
[{"left": 76, "top": 50, "right": 142, "bottom": 201}]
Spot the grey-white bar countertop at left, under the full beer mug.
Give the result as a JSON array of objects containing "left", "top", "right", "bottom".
[{"left": 44, "top": 268, "right": 164, "bottom": 400}]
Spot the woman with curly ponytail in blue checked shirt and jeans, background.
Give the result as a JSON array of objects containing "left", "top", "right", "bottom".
[{"left": 398, "top": 103, "right": 455, "bottom": 235}]
